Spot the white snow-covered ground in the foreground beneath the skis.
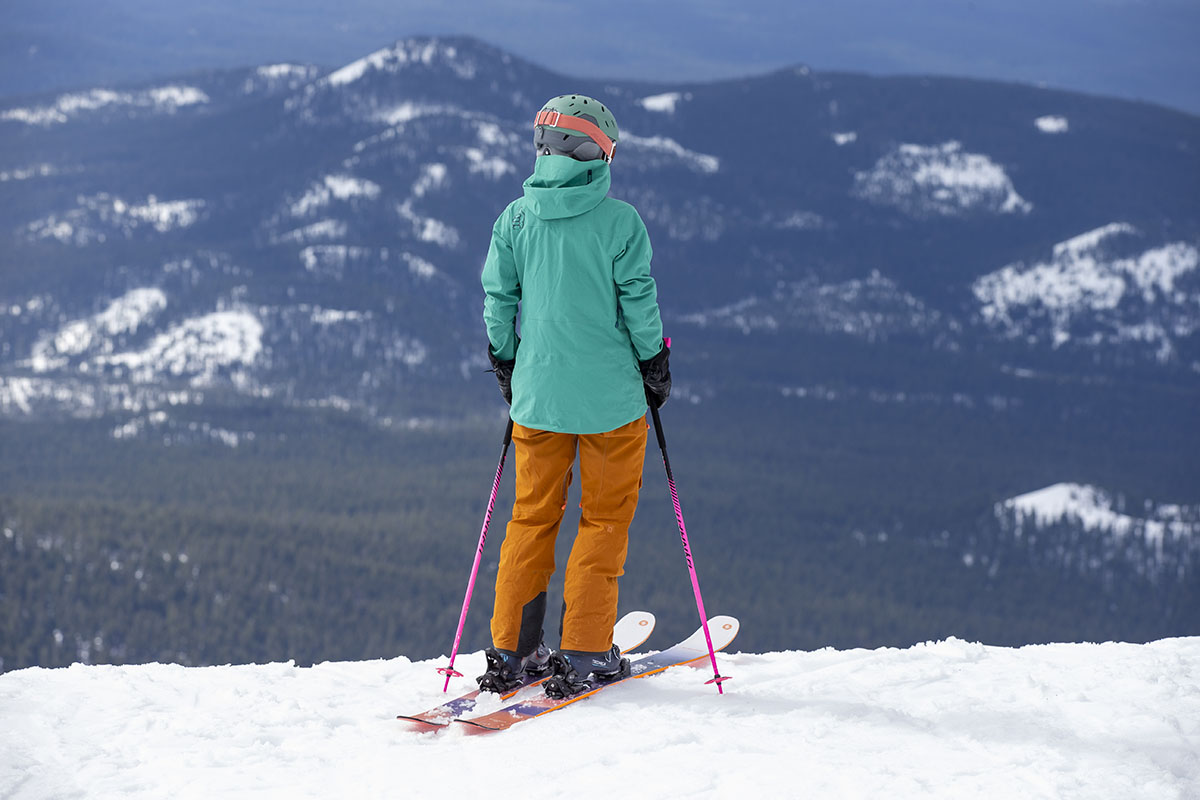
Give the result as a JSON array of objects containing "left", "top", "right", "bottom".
[{"left": 0, "top": 638, "right": 1200, "bottom": 800}]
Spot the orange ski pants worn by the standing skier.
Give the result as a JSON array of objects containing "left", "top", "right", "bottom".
[{"left": 492, "top": 417, "right": 646, "bottom": 656}]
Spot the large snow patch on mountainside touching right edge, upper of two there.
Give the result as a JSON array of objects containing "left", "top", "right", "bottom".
[{"left": 972, "top": 222, "right": 1200, "bottom": 361}]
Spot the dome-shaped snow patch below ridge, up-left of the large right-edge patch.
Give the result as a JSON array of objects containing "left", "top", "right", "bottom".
[{"left": 851, "top": 142, "right": 1033, "bottom": 218}]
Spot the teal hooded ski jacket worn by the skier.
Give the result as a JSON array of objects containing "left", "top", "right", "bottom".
[{"left": 482, "top": 156, "right": 662, "bottom": 433}]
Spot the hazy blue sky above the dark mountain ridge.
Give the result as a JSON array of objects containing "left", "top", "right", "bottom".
[{"left": 0, "top": 0, "right": 1200, "bottom": 113}]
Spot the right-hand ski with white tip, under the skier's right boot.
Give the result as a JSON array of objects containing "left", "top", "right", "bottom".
[{"left": 455, "top": 616, "right": 739, "bottom": 733}]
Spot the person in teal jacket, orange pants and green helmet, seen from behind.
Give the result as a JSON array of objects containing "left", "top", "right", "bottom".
[{"left": 478, "top": 95, "right": 671, "bottom": 697}]
